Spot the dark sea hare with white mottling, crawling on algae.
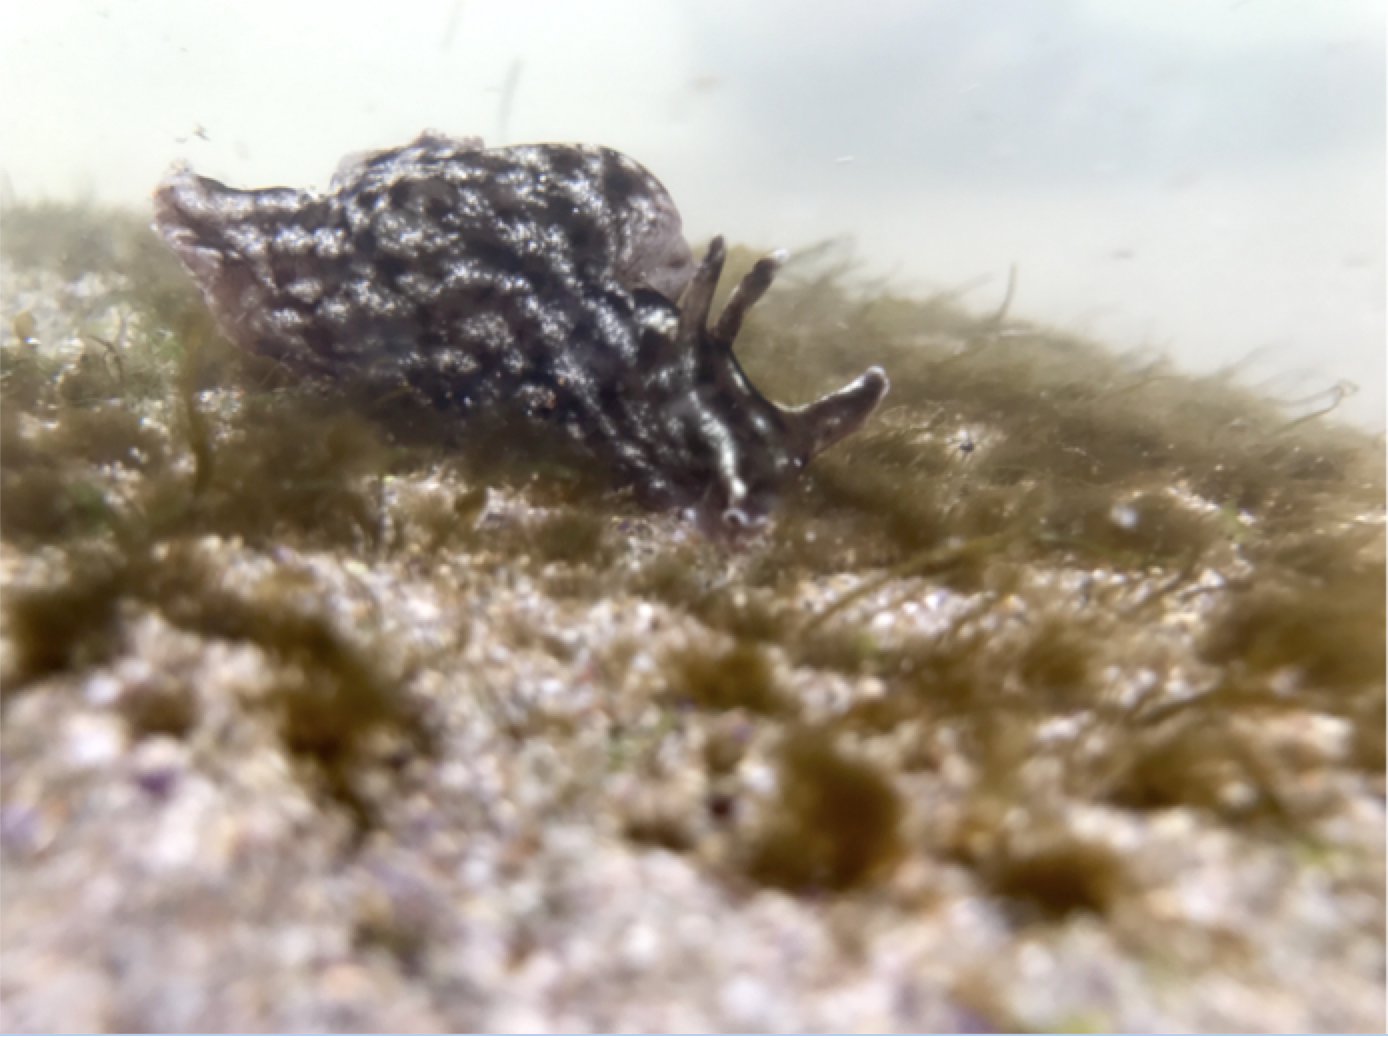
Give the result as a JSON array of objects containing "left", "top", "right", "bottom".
[{"left": 154, "top": 133, "right": 887, "bottom": 535}]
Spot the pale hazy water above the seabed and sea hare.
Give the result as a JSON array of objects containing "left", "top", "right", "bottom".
[{"left": 0, "top": 0, "right": 1385, "bottom": 429}]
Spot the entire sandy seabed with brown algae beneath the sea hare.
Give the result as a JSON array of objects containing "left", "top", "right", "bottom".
[{"left": 0, "top": 208, "right": 1385, "bottom": 1032}]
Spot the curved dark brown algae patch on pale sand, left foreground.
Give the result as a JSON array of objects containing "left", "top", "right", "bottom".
[{"left": 6, "top": 539, "right": 433, "bottom": 828}]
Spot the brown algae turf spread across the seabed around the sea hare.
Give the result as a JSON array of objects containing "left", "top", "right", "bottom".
[{"left": 0, "top": 207, "right": 1385, "bottom": 918}]
